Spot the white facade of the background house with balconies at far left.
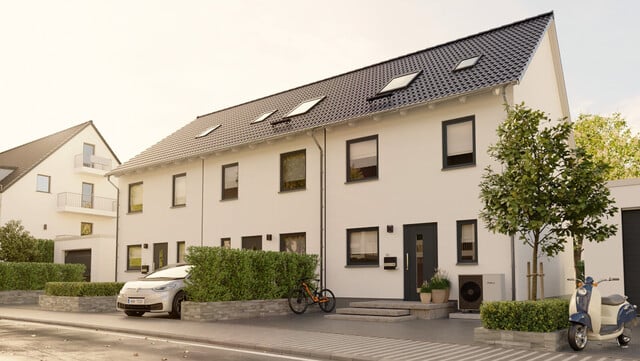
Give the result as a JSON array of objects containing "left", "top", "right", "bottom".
[{"left": 0, "top": 126, "right": 118, "bottom": 281}]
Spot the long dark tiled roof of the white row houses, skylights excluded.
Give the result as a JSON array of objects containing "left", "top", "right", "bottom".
[{"left": 111, "top": 12, "right": 553, "bottom": 175}]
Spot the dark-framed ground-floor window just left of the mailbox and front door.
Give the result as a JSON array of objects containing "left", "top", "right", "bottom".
[{"left": 347, "top": 227, "right": 380, "bottom": 266}]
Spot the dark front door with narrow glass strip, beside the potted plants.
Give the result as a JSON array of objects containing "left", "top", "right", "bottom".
[{"left": 404, "top": 223, "right": 438, "bottom": 301}]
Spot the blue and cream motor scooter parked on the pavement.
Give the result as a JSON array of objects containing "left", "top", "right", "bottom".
[{"left": 568, "top": 277, "right": 638, "bottom": 351}]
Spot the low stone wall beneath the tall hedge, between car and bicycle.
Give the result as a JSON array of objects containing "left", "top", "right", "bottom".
[{"left": 182, "top": 299, "right": 291, "bottom": 321}]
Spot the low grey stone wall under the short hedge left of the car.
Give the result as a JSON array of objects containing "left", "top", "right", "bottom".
[{"left": 38, "top": 295, "right": 117, "bottom": 313}]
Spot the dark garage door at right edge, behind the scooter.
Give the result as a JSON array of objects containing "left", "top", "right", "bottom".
[{"left": 622, "top": 209, "right": 640, "bottom": 305}]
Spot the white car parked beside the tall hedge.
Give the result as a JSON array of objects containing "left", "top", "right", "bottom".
[{"left": 116, "top": 264, "right": 192, "bottom": 318}]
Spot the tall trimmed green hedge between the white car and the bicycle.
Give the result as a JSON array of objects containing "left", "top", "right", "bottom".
[{"left": 185, "top": 247, "right": 318, "bottom": 302}]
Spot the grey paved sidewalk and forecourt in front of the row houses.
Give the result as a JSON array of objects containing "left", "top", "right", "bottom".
[{"left": 0, "top": 306, "right": 640, "bottom": 361}]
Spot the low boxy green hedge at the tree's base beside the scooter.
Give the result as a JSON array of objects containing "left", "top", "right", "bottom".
[{"left": 480, "top": 299, "right": 569, "bottom": 332}]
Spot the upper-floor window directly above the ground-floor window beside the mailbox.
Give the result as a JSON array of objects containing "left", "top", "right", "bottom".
[{"left": 347, "top": 135, "right": 378, "bottom": 182}]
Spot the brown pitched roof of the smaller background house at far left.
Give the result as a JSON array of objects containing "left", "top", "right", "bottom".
[{"left": 0, "top": 120, "right": 119, "bottom": 193}]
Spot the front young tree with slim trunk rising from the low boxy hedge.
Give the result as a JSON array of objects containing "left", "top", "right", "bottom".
[{"left": 480, "top": 103, "right": 571, "bottom": 300}]
